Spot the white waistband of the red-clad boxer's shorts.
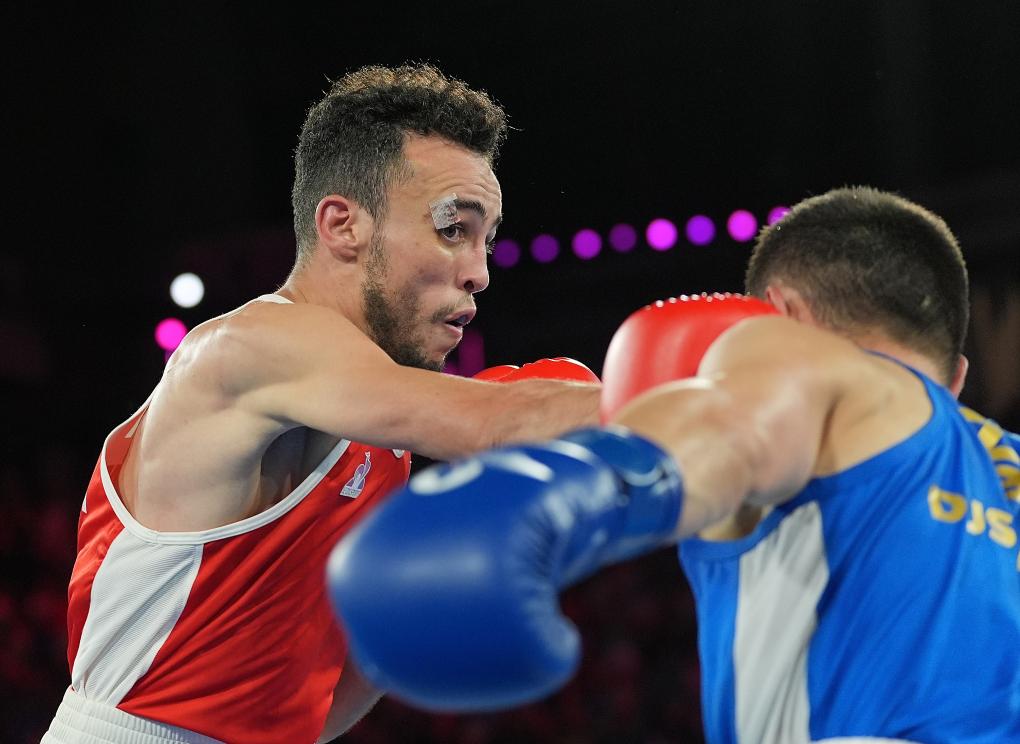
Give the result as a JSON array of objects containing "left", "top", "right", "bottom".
[{"left": 40, "top": 688, "right": 223, "bottom": 744}]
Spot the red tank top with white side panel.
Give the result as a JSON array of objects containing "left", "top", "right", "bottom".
[{"left": 67, "top": 404, "right": 410, "bottom": 744}]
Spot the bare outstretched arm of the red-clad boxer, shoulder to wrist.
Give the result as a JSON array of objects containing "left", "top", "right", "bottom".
[{"left": 213, "top": 304, "right": 599, "bottom": 459}]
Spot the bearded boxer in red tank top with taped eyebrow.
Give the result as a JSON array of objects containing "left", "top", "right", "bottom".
[{"left": 44, "top": 65, "right": 599, "bottom": 744}]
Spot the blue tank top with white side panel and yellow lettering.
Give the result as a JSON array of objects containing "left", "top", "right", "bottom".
[{"left": 679, "top": 357, "right": 1020, "bottom": 744}]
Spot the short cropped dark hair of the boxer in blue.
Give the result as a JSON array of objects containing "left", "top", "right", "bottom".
[{"left": 745, "top": 187, "right": 969, "bottom": 382}]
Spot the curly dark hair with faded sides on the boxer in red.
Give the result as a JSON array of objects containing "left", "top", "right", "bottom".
[{"left": 291, "top": 64, "right": 507, "bottom": 259}]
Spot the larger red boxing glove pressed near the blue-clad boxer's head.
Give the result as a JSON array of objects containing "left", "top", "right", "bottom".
[{"left": 600, "top": 293, "right": 777, "bottom": 423}]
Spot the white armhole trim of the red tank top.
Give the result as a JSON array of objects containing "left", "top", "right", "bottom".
[{"left": 99, "top": 295, "right": 351, "bottom": 545}]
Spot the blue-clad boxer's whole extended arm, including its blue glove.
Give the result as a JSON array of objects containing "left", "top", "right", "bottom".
[{"left": 328, "top": 309, "right": 930, "bottom": 710}]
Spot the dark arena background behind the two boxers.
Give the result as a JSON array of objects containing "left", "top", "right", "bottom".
[{"left": 0, "top": 0, "right": 1020, "bottom": 744}]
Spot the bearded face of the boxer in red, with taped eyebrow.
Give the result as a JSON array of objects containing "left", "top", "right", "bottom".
[{"left": 361, "top": 135, "right": 503, "bottom": 370}]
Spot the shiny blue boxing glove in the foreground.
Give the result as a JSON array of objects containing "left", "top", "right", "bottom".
[{"left": 327, "top": 428, "right": 683, "bottom": 711}]
